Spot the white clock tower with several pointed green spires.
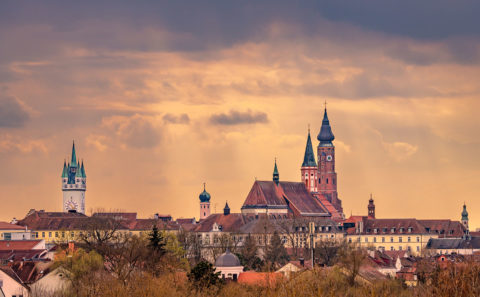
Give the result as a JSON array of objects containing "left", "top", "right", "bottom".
[{"left": 62, "top": 142, "right": 87, "bottom": 214}]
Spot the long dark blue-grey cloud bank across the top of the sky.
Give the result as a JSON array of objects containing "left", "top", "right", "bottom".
[{"left": 0, "top": 0, "right": 480, "bottom": 50}]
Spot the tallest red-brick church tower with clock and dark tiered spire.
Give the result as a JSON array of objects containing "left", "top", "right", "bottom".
[{"left": 317, "top": 107, "right": 343, "bottom": 212}]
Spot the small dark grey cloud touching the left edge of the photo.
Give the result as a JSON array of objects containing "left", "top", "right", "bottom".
[{"left": 0, "top": 95, "right": 30, "bottom": 127}]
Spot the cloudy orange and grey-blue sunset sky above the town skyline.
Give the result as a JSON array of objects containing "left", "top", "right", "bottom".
[{"left": 0, "top": 0, "right": 480, "bottom": 229}]
